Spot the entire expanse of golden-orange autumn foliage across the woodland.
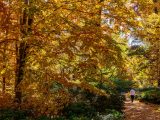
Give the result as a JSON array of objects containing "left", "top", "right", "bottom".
[{"left": 0, "top": 0, "right": 159, "bottom": 117}]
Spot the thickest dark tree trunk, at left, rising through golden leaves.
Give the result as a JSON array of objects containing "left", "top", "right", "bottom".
[{"left": 15, "top": 0, "right": 33, "bottom": 103}]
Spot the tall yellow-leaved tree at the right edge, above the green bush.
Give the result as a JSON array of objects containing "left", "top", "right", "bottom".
[{"left": 137, "top": 0, "right": 160, "bottom": 86}]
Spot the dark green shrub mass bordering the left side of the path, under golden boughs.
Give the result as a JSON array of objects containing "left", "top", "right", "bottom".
[{"left": 62, "top": 80, "right": 125, "bottom": 120}]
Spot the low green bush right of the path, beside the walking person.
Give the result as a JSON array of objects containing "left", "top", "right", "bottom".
[{"left": 139, "top": 88, "right": 160, "bottom": 104}]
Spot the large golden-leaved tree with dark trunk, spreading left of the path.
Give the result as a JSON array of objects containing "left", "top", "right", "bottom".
[{"left": 0, "top": 0, "right": 156, "bottom": 114}]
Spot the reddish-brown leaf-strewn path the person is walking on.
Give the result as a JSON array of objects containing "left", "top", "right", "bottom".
[{"left": 124, "top": 98, "right": 160, "bottom": 120}]
